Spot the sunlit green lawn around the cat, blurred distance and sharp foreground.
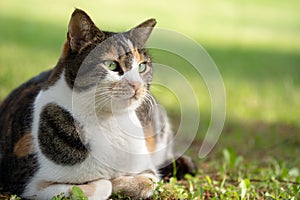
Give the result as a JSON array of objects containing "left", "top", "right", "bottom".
[{"left": 0, "top": 0, "right": 300, "bottom": 199}]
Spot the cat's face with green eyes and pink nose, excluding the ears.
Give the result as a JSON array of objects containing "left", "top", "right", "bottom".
[{"left": 95, "top": 34, "right": 153, "bottom": 112}]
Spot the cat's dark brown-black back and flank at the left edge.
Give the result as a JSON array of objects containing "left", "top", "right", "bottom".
[{"left": 0, "top": 70, "right": 51, "bottom": 193}]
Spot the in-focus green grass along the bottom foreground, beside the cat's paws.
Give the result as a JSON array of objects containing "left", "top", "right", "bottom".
[{"left": 0, "top": 148, "right": 300, "bottom": 200}]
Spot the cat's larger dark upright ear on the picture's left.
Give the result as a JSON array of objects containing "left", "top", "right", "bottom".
[{"left": 67, "top": 9, "right": 103, "bottom": 53}]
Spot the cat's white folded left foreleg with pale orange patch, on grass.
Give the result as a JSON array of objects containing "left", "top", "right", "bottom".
[{"left": 32, "top": 180, "right": 112, "bottom": 200}]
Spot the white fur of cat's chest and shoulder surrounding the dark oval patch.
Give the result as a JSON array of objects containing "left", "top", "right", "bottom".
[{"left": 22, "top": 70, "right": 156, "bottom": 199}]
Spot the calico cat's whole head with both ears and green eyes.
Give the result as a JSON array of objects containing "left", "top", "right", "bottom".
[{"left": 60, "top": 9, "right": 156, "bottom": 111}]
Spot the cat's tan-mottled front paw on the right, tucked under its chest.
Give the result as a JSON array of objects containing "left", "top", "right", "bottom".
[{"left": 112, "top": 173, "right": 159, "bottom": 199}]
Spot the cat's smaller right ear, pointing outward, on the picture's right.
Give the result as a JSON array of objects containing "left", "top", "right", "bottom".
[{"left": 129, "top": 19, "right": 156, "bottom": 48}]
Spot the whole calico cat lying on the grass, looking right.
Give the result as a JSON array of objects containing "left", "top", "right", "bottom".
[{"left": 0, "top": 9, "right": 195, "bottom": 199}]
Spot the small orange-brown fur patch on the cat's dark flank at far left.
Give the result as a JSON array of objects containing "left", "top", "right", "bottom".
[{"left": 14, "top": 133, "right": 34, "bottom": 158}]
